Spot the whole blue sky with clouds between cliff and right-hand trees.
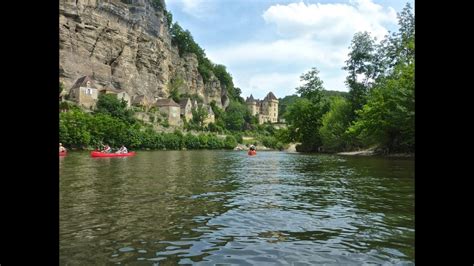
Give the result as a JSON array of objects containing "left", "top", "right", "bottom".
[{"left": 165, "top": 0, "right": 414, "bottom": 99}]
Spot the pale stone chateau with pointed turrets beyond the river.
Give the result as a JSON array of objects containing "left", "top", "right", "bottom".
[{"left": 245, "top": 92, "right": 278, "bottom": 124}]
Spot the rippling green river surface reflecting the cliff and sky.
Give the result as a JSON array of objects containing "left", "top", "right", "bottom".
[{"left": 60, "top": 151, "right": 414, "bottom": 265}]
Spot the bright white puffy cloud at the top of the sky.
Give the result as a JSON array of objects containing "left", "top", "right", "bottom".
[{"left": 263, "top": 0, "right": 397, "bottom": 41}]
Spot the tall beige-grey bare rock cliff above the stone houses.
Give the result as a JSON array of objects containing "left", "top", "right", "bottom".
[{"left": 59, "top": 0, "right": 223, "bottom": 106}]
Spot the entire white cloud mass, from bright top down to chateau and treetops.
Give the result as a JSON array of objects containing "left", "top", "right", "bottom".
[{"left": 206, "top": 0, "right": 397, "bottom": 97}]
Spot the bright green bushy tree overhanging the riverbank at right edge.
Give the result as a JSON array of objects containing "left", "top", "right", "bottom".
[{"left": 348, "top": 61, "right": 415, "bottom": 152}]
